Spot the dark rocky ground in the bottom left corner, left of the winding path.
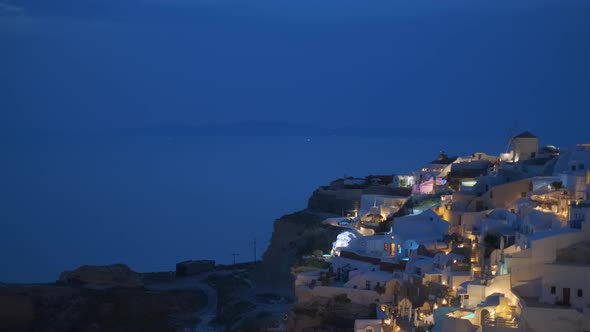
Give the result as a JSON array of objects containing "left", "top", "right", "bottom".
[{"left": 0, "top": 285, "right": 207, "bottom": 332}]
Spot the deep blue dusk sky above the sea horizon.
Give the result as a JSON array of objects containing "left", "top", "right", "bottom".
[{"left": 0, "top": 0, "right": 590, "bottom": 140}]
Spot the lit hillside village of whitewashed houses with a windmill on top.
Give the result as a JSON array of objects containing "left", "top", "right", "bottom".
[{"left": 296, "top": 131, "right": 590, "bottom": 332}]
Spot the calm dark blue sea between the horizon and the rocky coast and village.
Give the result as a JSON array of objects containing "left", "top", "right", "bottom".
[{"left": 0, "top": 133, "right": 503, "bottom": 282}]
